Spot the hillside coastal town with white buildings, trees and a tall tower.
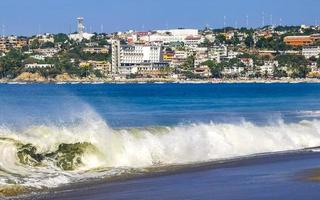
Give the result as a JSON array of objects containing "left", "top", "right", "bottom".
[{"left": 0, "top": 17, "right": 320, "bottom": 82}]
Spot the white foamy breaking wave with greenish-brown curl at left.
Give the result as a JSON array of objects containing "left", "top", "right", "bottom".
[{"left": 0, "top": 110, "right": 320, "bottom": 188}]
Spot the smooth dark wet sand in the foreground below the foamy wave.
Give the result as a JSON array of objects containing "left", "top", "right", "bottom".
[{"left": 15, "top": 152, "right": 320, "bottom": 200}]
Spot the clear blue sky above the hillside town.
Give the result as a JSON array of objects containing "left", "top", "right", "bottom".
[{"left": 0, "top": 0, "right": 320, "bottom": 35}]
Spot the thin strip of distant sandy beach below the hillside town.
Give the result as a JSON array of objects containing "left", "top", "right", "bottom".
[{"left": 0, "top": 78, "right": 320, "bottom": 84}]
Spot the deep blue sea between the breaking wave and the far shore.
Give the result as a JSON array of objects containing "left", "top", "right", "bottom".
[{"left": 0, "top": 84, "right": 320, "bottom": 127}]
